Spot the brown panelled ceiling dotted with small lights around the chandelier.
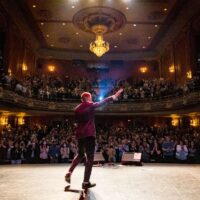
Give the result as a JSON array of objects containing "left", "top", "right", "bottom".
[{"left": 16, "top": 0, "right": 188, "bottom": 57}]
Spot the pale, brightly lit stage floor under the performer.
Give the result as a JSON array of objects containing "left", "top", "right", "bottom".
[{"left": 0, "top": 164, "right": 200, "bottom": 200}]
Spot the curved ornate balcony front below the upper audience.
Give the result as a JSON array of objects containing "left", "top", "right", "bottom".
[{"left": 0, "top": 87, "right": 200, "bottom": 115}]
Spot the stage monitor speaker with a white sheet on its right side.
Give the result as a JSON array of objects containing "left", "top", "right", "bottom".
[{"left": 121, "top": 152, "right": 142, "bottom": 166}]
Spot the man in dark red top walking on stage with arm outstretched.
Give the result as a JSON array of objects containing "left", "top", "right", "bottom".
[{"left": 65, "top": 89, "right": 123, "bottom": 189}]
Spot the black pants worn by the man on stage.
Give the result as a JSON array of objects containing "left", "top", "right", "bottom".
[{"left": 69, "top": 137, "right": 95, "bottom": 182}]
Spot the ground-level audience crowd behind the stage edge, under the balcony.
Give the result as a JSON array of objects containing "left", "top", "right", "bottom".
[{"left": 0, "top": 121, "right": 200, "bottom": 164}]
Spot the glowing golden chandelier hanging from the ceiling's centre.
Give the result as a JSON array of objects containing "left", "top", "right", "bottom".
[{"left": 90, "top": 24, "right": 110, "bottom": 57}]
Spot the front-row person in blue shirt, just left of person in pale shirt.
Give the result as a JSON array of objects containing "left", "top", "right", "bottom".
[{"left": 162, "top": 136, "right": 174, "bottom": 162}]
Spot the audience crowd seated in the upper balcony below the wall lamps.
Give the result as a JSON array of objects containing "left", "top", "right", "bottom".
[{"left": 0, "top": 74, "right": 200, "bottom": 101}]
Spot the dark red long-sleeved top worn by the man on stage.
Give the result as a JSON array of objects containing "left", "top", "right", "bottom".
[{"left": 75, "top": 96, "right": 113, "bottom": 139}]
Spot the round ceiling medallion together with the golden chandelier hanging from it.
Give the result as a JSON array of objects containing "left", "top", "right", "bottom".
[{"left": 73, "top": 7, "right": 126, "bottom": 57}]
